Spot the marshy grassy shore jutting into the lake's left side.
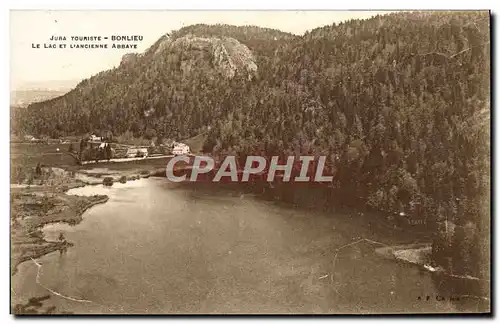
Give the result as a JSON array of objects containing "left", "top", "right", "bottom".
[{"left": 10, "top": 158, "right": 162, "bottom": 275}]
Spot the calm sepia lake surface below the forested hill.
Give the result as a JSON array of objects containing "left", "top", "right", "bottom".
[{"left": 12, "top": 178, "right": 490, "bottom": 313}]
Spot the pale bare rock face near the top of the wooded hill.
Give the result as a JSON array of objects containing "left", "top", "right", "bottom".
[{"left": 155, "top": 35, "right": 258, "bottom": 79}]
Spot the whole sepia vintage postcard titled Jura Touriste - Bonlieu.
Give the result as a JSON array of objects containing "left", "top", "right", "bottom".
[{"left": 10, "top": 10, "right": 491, "bottom": 315}]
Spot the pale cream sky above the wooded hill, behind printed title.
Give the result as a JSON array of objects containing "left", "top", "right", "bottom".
[{"left": 10, "top": 10, "right": 388, "bottom": 90}]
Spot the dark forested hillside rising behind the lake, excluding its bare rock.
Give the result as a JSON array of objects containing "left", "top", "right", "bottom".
[{"left": 11, "top": 12, "right": 490, "bottom": 277}]
